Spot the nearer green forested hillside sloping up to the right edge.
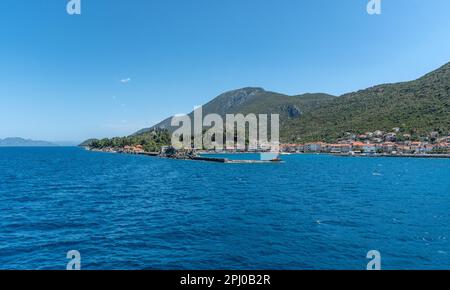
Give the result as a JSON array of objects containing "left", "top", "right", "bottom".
[{"left": 281, "top": 63, "right": 450, "bottom": 142}]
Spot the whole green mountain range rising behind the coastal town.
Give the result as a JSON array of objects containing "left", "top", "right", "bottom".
[{"left": 134, "top": 63, "right": 450, "bottom": 142}]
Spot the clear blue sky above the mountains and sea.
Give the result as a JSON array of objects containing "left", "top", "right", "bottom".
[{"left": 0, "top": 0, "right": 450, "bottom": 141}]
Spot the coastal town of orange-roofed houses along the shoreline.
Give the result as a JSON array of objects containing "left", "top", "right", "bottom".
[{"left": 86, "top": 128, "right": 450, "bottom": 159}]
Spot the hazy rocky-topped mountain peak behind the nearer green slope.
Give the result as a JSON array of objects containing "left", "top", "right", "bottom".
[{"left": 133, "top": 88, "right": 334, "bottom": 135}]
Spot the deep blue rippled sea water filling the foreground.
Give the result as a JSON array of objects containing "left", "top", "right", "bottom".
[{"left": 0, "top": 148, "right": 450, "bottom": 269}]
